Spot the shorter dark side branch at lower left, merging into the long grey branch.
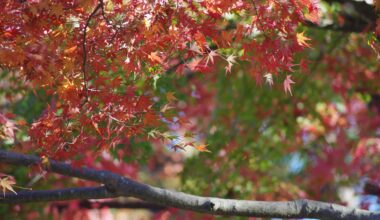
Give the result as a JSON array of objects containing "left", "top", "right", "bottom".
[{"left": 0, "top": 186, "right": 117, "bottom": 203}]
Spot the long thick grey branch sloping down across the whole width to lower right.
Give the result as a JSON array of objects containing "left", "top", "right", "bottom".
[{"left": 0, "top": 150, "right": 380, "bottom": 219}]
